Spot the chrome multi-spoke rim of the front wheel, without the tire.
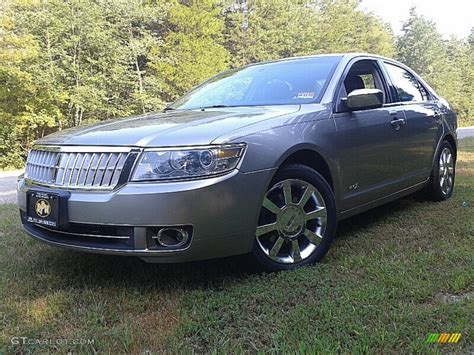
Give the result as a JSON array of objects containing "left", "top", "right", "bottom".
[{"left": 256, "top": 179, "right": 327, "bottom": 264}]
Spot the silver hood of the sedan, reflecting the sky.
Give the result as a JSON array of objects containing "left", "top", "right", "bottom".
[{"left": 36, "top": 105, "right": 300, "bottom": 147}]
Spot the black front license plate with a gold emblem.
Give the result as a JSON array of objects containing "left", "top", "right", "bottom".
[{"left": 26, "top": 191, "right": 60, "bottom": 228}]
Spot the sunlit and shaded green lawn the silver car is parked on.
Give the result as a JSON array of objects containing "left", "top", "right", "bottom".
[{"left": 0, "top": 139, "right": 474, "bottom": 353}]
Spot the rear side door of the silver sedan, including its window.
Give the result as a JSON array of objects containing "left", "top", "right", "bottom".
[{"left": 384, "top": 62, "right": 443, "bottom": 185}]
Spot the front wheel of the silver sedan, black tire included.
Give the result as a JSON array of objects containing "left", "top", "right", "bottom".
[{"left": 253, "top": 164, "right": 337, "bottom": 271}]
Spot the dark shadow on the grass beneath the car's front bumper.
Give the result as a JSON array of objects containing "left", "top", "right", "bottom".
[{"left": 30, "top": 250, "right": 259, "bottom": 291}]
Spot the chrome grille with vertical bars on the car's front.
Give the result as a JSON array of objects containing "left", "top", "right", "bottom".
[{"left": 25, "top": 147, "right": 129, "bottom": 188}]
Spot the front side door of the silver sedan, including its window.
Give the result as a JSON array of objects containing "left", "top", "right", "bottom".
[{"left": 333, "top": 59, "right": 408, "bottom": 210}]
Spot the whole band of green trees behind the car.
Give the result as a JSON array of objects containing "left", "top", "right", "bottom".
[{"left": 0, "top": 0, "right": 474, "bottom": 168}]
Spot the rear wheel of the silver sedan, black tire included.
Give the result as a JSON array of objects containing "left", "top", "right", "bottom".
[{"left": 427, "top": 141, "right": 456, "bottom": 202}]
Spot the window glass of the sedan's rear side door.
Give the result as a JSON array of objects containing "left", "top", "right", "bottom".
[{"left": 385, "top": 63, "right": 428, "bottom": 102}]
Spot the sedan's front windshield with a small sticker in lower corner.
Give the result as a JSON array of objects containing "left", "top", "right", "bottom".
[{"left": 169, "top": 56, "right": 341, "bottom": 109}]
